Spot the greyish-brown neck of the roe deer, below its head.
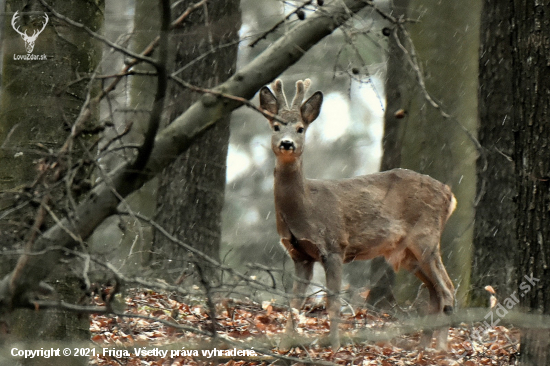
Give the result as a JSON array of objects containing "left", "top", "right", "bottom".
[{"left": 274, "top": 159, "right": 309, "bottom": 219}]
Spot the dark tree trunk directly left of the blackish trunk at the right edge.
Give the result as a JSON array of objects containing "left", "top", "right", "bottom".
[{"left": 470, "top": 1, "right": 517, "bottom": 306}]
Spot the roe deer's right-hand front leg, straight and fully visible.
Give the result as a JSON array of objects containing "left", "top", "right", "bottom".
[{"left": 321, "top": 253, "right": 343, "bottom": 352}]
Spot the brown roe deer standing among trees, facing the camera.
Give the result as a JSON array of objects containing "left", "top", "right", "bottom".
[{"left": 260, "top": 79, "right": 456, "bottom": 350}]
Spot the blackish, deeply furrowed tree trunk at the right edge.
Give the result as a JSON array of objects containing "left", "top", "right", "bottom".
[{"left": 511, "top": 0, "right": 550, "bottom": 365}]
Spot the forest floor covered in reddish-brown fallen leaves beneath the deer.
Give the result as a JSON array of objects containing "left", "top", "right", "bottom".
[{"left": 90, "top": 290, "right": 519, "bottom": 366}]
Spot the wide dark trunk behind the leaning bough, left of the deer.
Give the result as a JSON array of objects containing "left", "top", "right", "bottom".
[{"left": 153, "top": 0, "right": 241, "bottom": 280}]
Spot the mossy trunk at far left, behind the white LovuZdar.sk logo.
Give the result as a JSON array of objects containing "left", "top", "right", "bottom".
[{"left": 0, "top": 0, "right": 103, "bottom": 365}]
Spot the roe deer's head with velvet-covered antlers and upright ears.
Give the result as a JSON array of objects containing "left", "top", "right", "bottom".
[{"left": 260, "top": 79, "right": 323, "bottom": 162}]
